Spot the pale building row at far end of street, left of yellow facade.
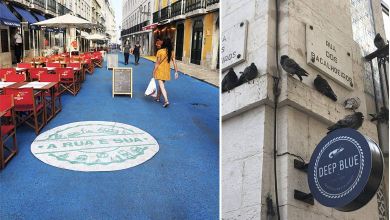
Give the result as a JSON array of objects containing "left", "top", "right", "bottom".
[{"left": 121, "top": 0, "right": 154, "bottom": 55}]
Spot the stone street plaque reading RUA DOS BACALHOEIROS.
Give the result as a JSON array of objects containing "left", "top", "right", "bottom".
[{"left": 306, "top": 24, "right": 354, "bottom": 90}]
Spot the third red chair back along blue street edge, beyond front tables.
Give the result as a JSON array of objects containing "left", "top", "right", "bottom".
[{"left": 56, "top": 68, "right": 80, "bottom": 96}]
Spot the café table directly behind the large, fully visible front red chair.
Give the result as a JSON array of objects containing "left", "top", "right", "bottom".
[{"left": 8, "top": 82, "right": 57, "bottom": 123}]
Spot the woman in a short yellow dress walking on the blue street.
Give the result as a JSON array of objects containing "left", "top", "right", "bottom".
[{"left": 153, "top": 37, "right": 179, "bottom": 108}]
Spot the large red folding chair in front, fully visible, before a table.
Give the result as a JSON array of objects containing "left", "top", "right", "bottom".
[{"left": 4, "top": 88, "right": 46, "bottom": 135}]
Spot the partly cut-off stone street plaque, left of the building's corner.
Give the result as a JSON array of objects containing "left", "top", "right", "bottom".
[{"left": 221, "top": 20, "right": 248, "bottom": 71}]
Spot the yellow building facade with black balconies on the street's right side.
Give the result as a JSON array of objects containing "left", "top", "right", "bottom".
[{"left": 153, "top": 0, "right": 220, "bottom": 70}]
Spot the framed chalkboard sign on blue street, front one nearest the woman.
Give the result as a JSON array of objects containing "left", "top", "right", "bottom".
[{"left": 112, "top": 67, "right": 133, "bottom": 97}]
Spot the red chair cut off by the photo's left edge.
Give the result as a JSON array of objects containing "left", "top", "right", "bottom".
[{"left": 0, "top": 95, "right": 18, "bottom": 169}]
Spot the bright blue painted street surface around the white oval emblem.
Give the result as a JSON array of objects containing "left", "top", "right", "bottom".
[{"left": 0, "top": 54, "right": 219, "bottom": 220}]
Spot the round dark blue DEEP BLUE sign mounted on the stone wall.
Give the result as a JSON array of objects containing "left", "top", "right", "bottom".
[{"left": 308, "top": 128, "right": 383, "bottom": 212}]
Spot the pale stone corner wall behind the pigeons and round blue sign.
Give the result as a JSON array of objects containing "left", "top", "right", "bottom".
[{"left": 221, "top": 0, "right": 389, "bottom": 220}]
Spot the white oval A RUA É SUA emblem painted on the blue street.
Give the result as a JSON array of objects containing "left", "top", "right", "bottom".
[{"left": 31, "top": 121, "right": 159, "bottom": 172}]
